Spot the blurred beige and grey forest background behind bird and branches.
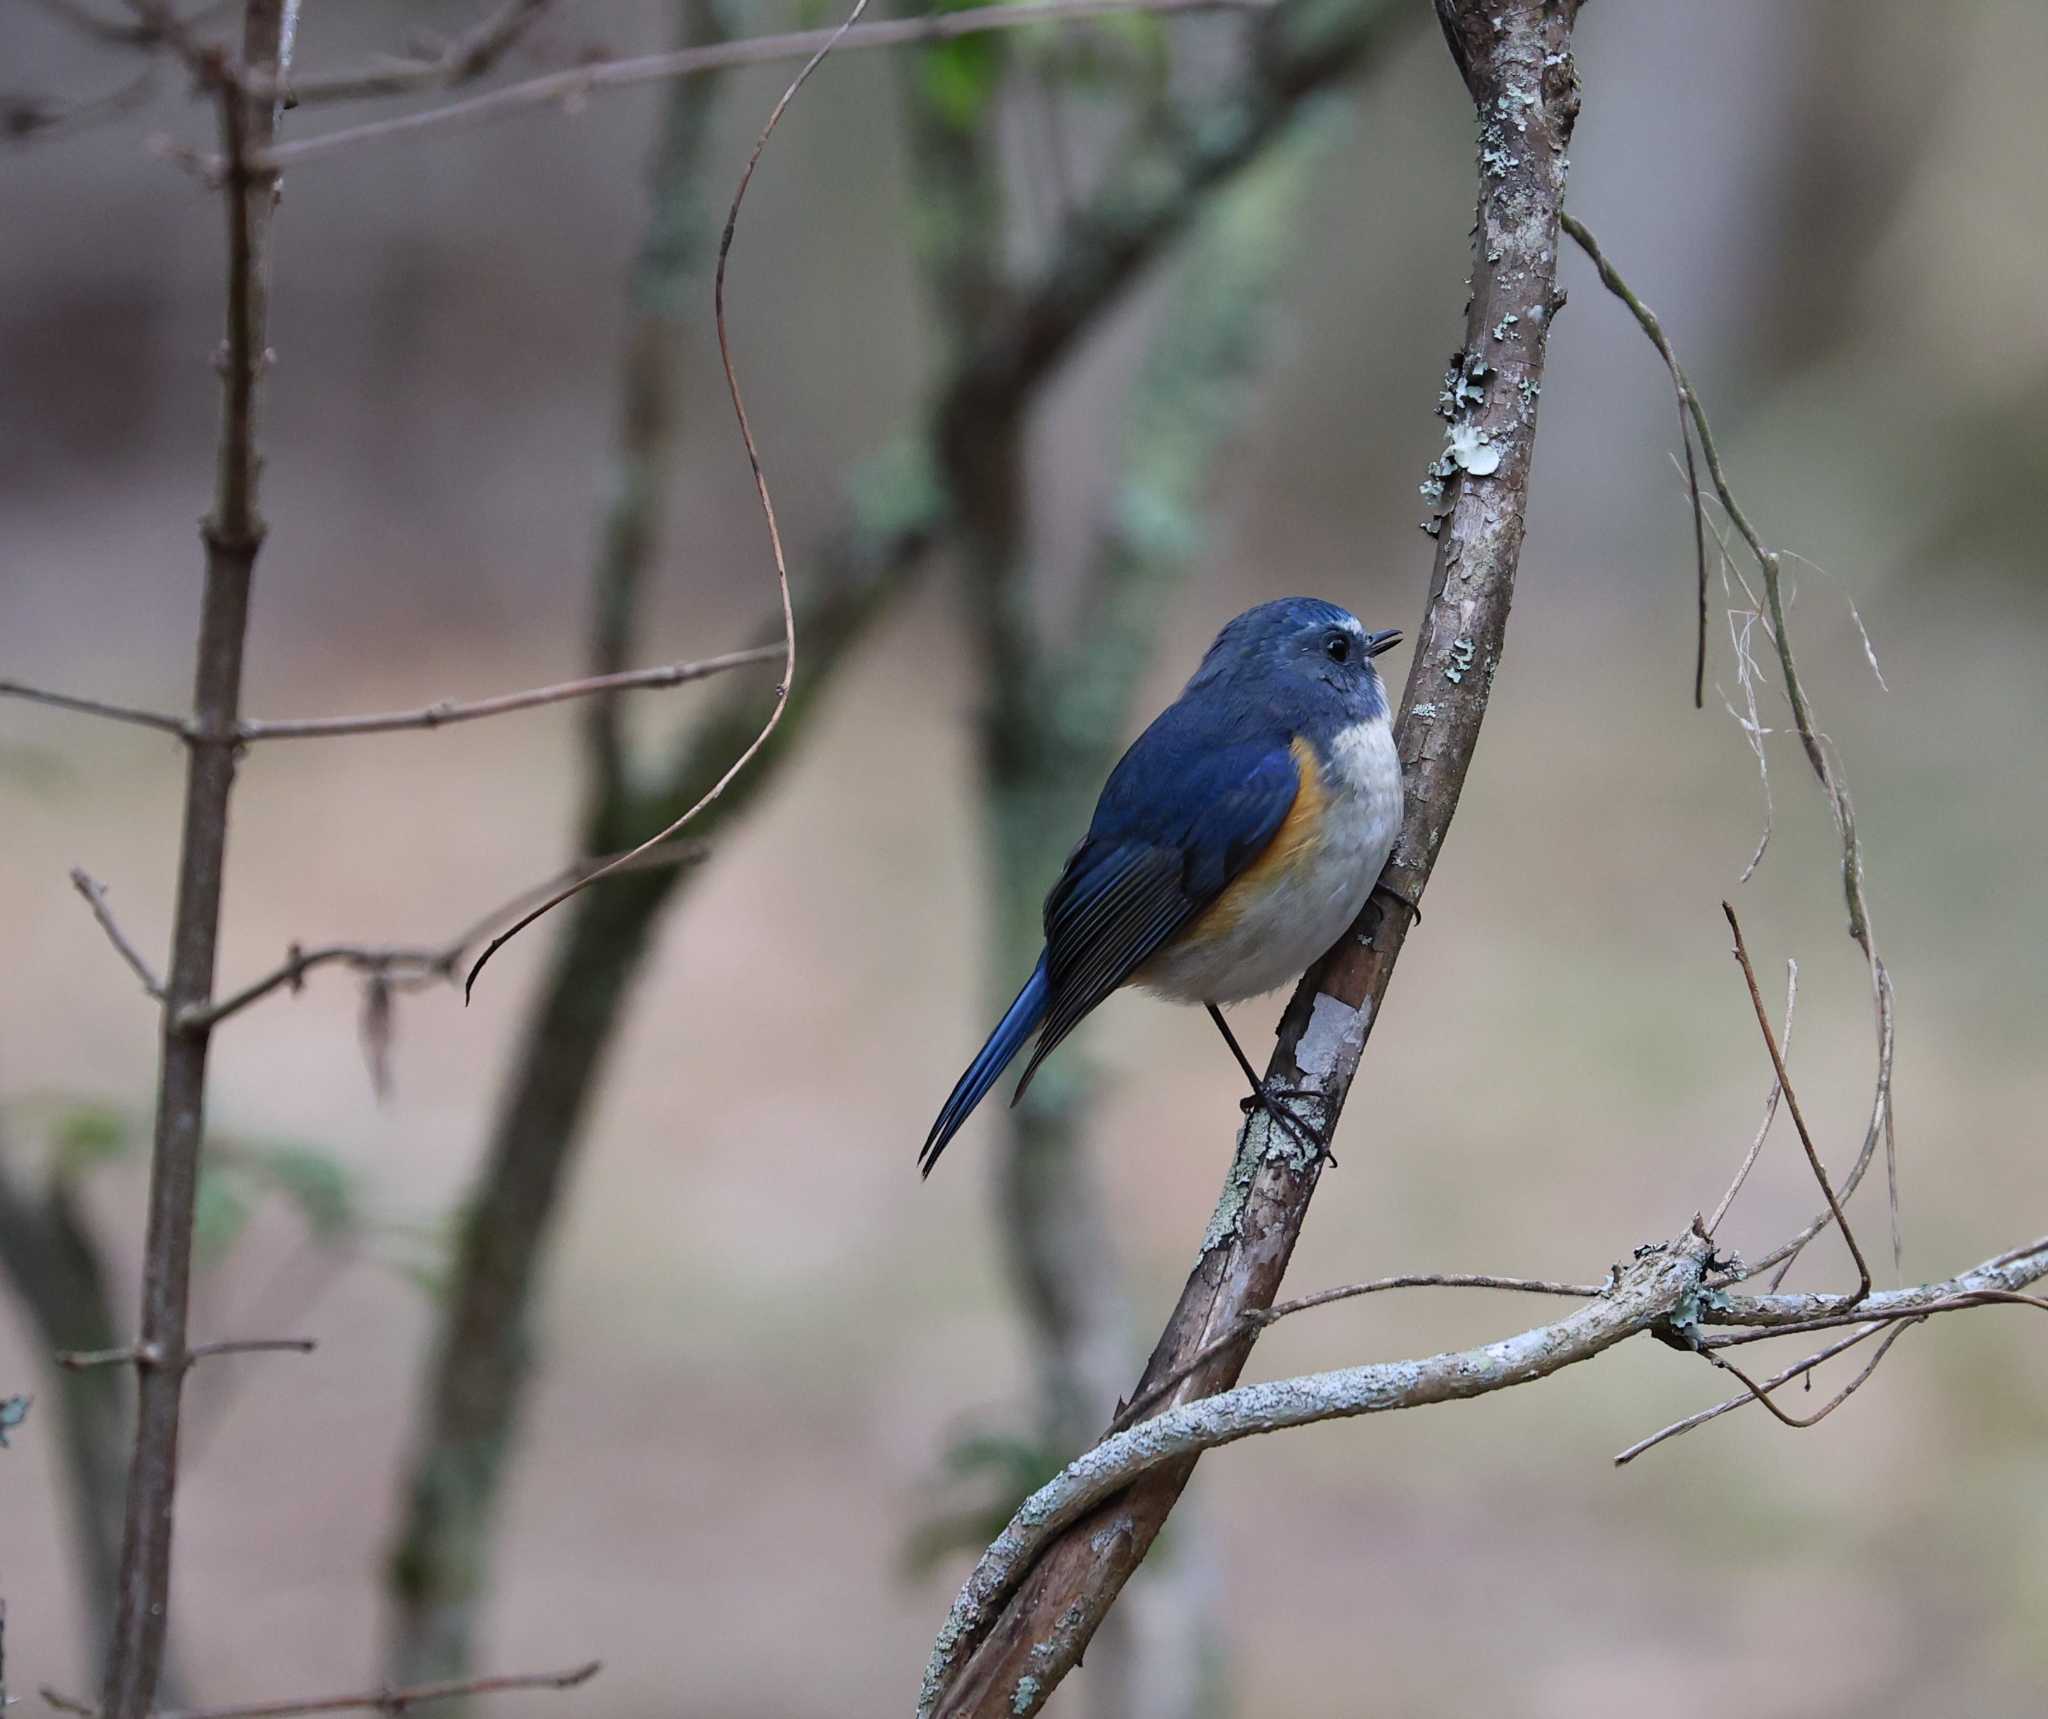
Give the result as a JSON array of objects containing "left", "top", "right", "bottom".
[{"left": 0, "top": 0, "right": 2048, "bottom": 1719}]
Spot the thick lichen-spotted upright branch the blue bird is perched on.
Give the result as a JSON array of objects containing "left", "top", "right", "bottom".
[{"left": 920, "top": 0, "right": 1579, "bottom": 1715}]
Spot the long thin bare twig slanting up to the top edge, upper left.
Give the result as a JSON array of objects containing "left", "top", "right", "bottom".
[{"left": 249, "top": 0, "right": 1274, "bottom": 178}]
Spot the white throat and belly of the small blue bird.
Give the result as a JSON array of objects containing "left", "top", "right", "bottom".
[{"left": 1139, "top": 717, "right": 1401, "bottom": 1002}]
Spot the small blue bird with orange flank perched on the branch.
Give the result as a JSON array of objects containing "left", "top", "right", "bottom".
[{"left": 918, "top": 596, "right": 1401, "bottom": 1176}]
